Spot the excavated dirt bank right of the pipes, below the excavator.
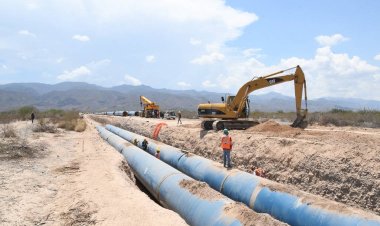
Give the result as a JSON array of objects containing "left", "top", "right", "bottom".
[{"left": 97, "top": 116, "right": 380, "bottom": 215}]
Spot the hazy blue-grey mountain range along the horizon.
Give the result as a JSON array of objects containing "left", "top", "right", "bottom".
[{"left": 0, "top": 82, "right": 380, "bottom": 111}]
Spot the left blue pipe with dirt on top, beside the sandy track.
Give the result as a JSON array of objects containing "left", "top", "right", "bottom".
[{"left": 97, "top": 126, "right": 286, "bottom": 225}]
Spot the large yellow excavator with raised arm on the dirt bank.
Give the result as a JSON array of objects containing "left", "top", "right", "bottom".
[{"left": 198, "top": 66, "right": 307, "bottom": 130}]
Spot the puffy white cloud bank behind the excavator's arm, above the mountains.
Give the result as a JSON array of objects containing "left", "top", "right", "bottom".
[{"left": 217, "top": 47, "right": 380, "bottom": 100}]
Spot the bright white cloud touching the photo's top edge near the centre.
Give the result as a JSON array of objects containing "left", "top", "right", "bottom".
[{"left": 87, "top": 0, "right": 258, "bottom": 42}]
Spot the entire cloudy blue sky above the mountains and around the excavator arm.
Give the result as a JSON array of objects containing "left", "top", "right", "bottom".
[{"left": 0, "top": 0, "right": 380, "bottom": 100}]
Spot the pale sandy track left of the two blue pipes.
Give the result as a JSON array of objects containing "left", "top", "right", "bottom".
[{"left": 0, "top": 119, "right": 187, "bottom": 226}]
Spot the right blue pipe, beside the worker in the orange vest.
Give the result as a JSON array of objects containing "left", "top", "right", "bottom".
[{"left": 106, "top": 125, "right": 380, "bottom": 226}]
